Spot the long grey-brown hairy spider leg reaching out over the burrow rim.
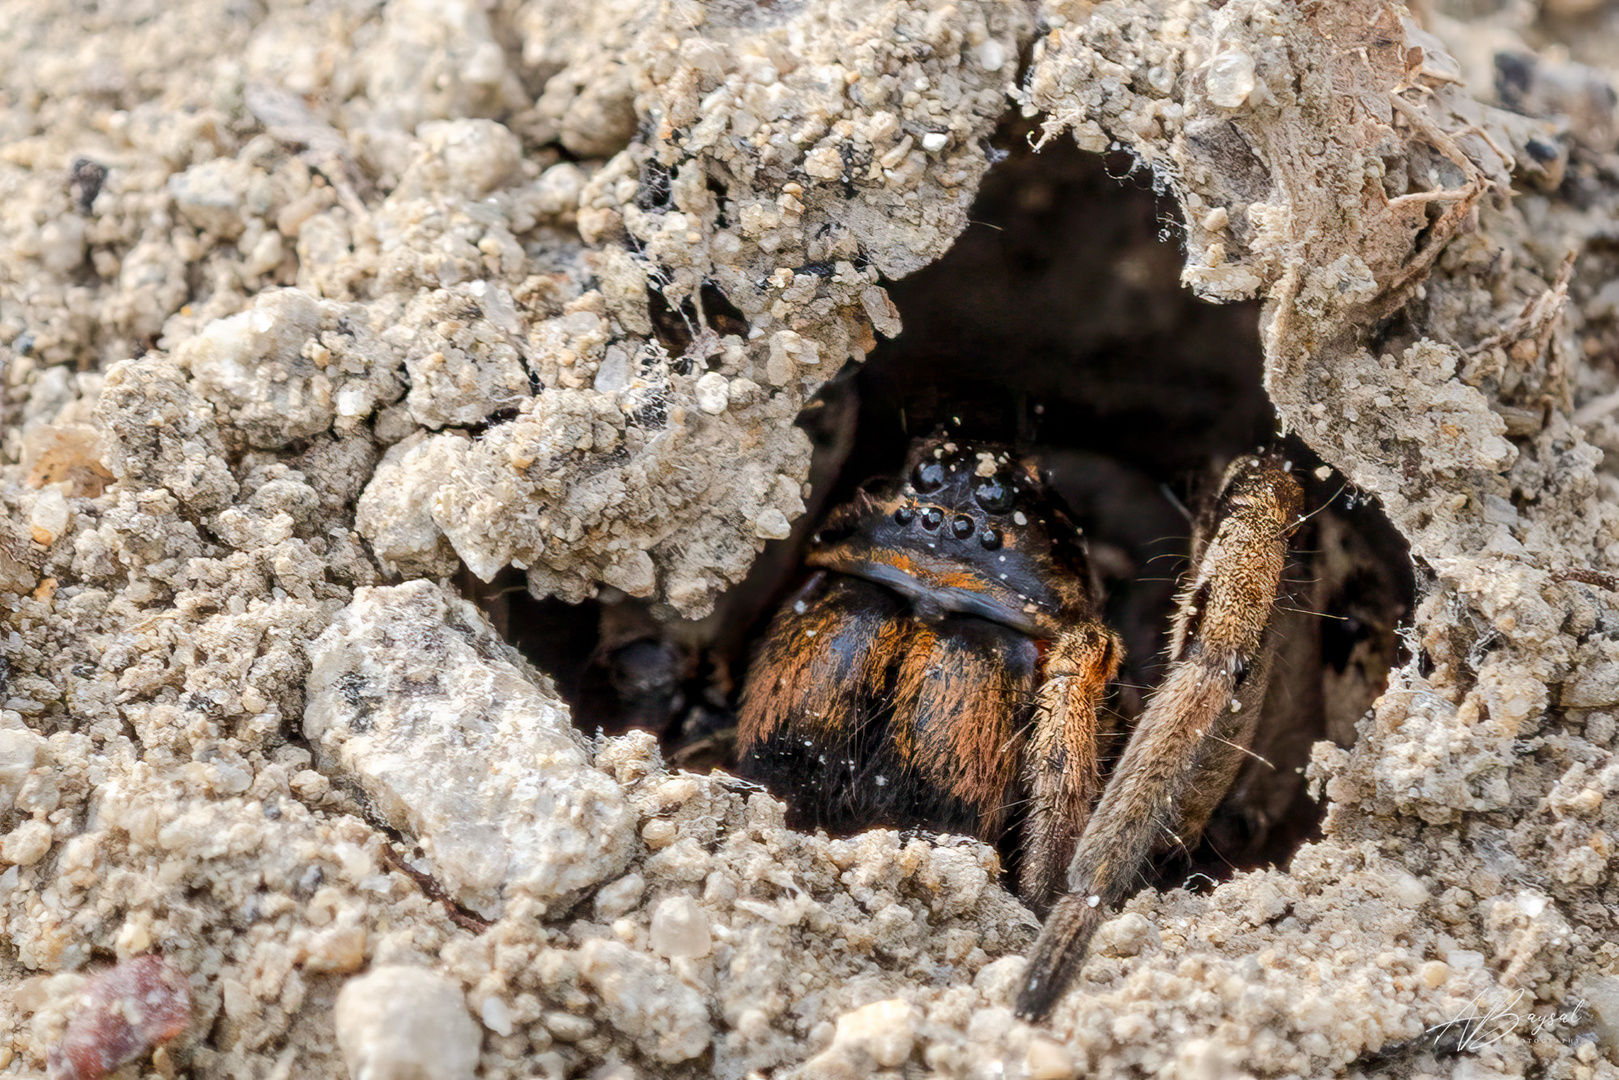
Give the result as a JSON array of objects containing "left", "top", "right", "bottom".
[{"left": 1017, "top": 457, "right": 1303, "bottom": 1018}]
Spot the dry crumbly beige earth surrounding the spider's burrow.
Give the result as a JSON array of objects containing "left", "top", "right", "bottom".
[{"left": 0, "top": 0, "right": 1619, "bottom": 1078}]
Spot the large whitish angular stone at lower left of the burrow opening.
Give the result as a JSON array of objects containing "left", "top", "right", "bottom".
[{"left": 303, "top": 581, "right": 635, "bottom": 918}]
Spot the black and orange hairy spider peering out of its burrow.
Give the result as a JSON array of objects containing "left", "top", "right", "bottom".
[{"left": 738, "top": 432, "right": 1303, "bottom": 1018}]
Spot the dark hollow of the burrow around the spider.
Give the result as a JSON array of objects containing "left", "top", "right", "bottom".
[{"left": 476, "top": 125, "right": 1413, "bottom": 884}]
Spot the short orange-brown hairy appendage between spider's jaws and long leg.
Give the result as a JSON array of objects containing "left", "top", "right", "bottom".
[{"left": 1018, "top": 623, "right": 1124, "bottom": 915}]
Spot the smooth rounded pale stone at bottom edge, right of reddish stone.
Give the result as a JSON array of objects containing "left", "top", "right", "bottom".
[{"left": 337, "top": 967, "right": 482, "bottom": 1080}]
